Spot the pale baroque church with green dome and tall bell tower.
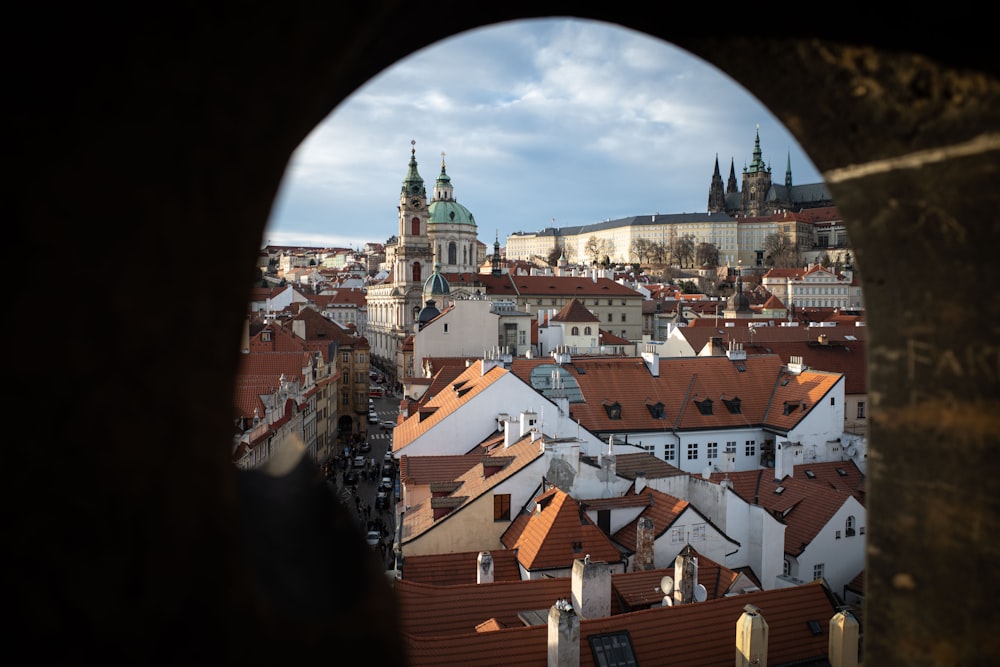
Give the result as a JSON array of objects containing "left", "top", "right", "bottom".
[{"left": 367, "top": 141, "right": 485, "bottom": 386}]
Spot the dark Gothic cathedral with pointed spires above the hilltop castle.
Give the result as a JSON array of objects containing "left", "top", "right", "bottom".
[{"left": 708, "top": 126, "right": 833, "bottom": 218}]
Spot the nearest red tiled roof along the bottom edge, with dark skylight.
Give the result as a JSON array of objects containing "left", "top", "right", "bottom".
[{"left": 397, "top": 578, "right": 837, "bottom": 667}]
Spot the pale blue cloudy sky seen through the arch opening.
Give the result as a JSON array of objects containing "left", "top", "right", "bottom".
[{"left": 262, "top": 19, "right": 822, "bottom": 253}]
